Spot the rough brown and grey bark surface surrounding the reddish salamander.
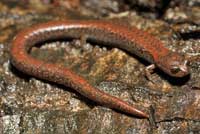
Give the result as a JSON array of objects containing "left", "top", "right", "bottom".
[{"left": 0, "top": 0, "right": 200, "bottom": 134}]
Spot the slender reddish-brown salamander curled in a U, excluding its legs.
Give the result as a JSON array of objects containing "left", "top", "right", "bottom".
[{"left": 10, "top": 21, "right": 188, "bottom": 118}]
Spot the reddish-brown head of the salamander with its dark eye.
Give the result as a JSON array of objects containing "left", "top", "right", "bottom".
[{"left": 157, "top": 52, "right": 189, "bottom": 77}]
